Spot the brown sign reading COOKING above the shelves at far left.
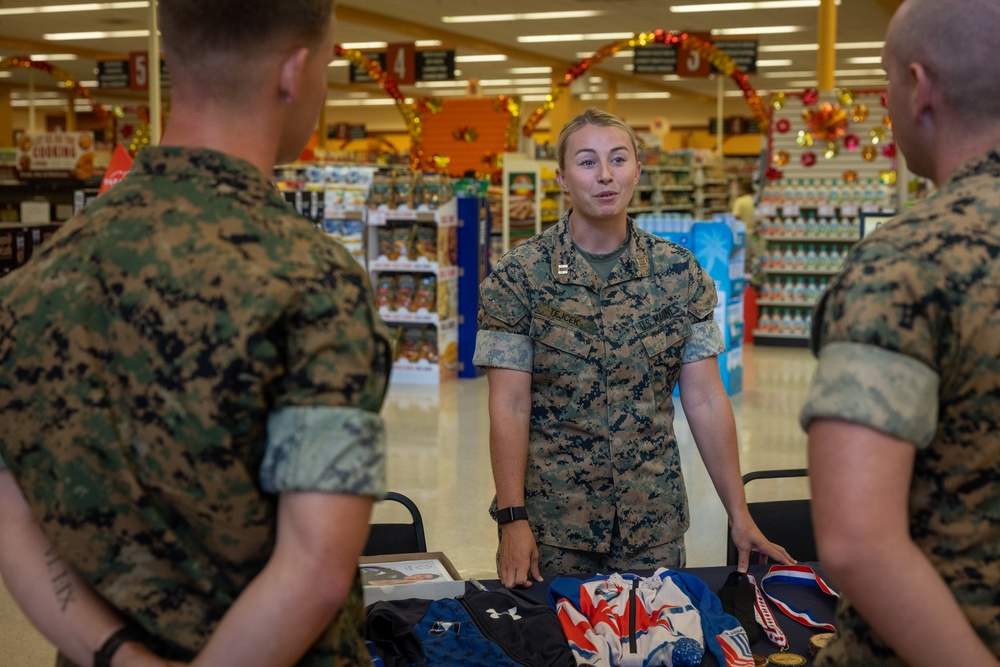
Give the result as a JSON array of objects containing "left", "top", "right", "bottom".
[{"left": 17, "top": 132, "right": 94, "bottom": 181}]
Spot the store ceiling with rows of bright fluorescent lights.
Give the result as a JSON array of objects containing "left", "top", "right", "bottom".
[{"left": 0, "top": 0, "right": 901, "bottom": 126}]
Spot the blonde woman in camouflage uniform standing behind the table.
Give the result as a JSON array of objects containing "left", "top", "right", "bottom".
[{"left": 475, "top": 109, "right": 790, "bottom": 587}]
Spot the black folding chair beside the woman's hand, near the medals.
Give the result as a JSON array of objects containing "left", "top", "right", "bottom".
[{"left": 726, "top": 468, "right": 818, "bottom": 567}]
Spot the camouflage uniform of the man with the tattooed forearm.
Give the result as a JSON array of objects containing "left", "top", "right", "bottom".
[{"left": 0, "top": 147, "right": 390, "bottom": 666}]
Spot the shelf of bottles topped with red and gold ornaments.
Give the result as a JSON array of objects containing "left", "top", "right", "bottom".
[{"left": 752, "top": 90, "right": 897, "bottom": 346}]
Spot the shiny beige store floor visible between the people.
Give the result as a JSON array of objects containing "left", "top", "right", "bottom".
[{"left": 0, "top": 345, "right": 815, "bottom": 667}]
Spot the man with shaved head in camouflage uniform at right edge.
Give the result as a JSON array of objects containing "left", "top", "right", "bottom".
[{"left": 802, "top": 0, "right": 1000, "bottom": 666}]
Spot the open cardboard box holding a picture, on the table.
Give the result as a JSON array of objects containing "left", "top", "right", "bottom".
[{"left": 358, "top": 551, "right": 465, "bottom": 606}]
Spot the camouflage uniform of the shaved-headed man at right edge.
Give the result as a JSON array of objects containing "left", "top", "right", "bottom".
[{"left": 802, "top": 151, "right": 1000, "bottom": 667}]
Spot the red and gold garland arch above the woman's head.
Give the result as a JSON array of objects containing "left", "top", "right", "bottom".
[{"left": 522, "top": 30, "right": 770, "bottom": 137}]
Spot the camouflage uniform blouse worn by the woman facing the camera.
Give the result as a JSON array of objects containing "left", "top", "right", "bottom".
[{"left": 475, "top": 214, "right": 724, "bottom": 553}]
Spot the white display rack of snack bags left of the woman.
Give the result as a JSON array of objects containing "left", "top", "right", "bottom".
[{"left": 368, "top": 198, "right": 459, "bottom": 384}]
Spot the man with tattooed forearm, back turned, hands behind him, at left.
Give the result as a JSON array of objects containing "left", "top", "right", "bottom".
[{"left": 0, "top": 0, "right": 389, "bottom": 667}]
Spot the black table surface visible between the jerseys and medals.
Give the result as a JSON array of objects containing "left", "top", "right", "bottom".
[{"left": 482, "top": 563, "right": 836, "bottom": 667}]
